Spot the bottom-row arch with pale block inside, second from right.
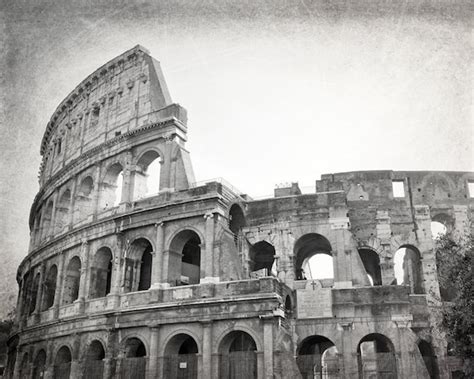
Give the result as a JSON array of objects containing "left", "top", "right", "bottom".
[{"left": 357, "top": 333, "right": 397, "bottom": 379}]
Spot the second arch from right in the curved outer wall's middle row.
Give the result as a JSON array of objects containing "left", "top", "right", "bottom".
[{"left": 124, "top": 238, "right": 153, "bottom": 292}]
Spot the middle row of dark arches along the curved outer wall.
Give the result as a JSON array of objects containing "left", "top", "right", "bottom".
[{"left": 20, "top": 229, "right": 201, "bottom": 314}]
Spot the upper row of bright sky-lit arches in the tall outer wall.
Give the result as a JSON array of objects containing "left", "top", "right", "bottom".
[{"left": 34, "top": 150, "right": 162, "bottom": 242}]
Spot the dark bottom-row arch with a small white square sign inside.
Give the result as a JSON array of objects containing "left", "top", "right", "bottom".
[{"left": 163, "top": 334, "right": 198, "bottom": 379}]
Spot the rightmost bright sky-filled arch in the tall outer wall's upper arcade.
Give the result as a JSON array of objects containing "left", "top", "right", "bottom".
[{"left": 133, "top": 150, "right": 161, "bottom": 200}]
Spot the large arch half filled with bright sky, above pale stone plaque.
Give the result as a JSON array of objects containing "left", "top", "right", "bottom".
[{"left": 294, "top": 233, "right": 334, "bottom": 280}]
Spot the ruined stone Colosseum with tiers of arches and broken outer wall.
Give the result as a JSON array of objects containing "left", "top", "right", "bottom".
[{"left": 7, "top": 46, "right": 474, "bottom": 379}]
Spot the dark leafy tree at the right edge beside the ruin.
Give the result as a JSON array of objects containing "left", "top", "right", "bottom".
[{"left": 436, "top": 234, "right": 474, "bottom": 378}]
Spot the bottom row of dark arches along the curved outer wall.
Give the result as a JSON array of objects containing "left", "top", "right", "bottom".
[{"left": 19, "top": 331, "right": 257, "bottom": 379}]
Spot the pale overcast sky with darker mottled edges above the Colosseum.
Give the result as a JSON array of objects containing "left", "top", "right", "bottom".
[{"left": 0, "top": 0, "right": 473, "bottom": 314}]
